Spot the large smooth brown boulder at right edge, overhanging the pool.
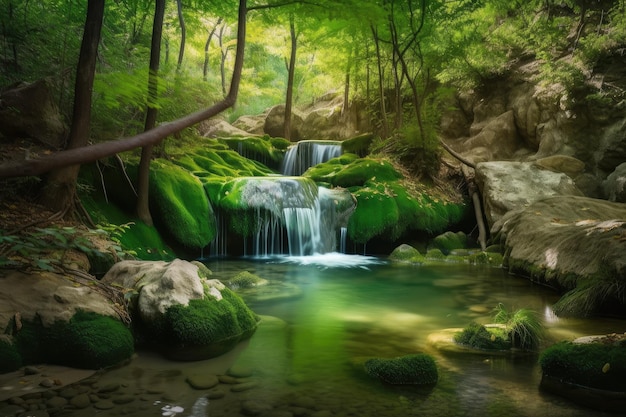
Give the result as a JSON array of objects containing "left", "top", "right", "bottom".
[{"left": 492, "top": 195, "right": 626, "bottom": 315}]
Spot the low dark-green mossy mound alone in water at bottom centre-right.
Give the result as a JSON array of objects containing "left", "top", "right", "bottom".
[{"left": 365, "top": 354, "right": 439, "bottom": 385}]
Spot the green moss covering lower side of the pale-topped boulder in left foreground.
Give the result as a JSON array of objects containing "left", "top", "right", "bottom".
[{"left": 162, "top": 288, "right": 257, "bottom": 347}]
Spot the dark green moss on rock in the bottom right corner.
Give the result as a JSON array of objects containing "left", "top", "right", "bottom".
[{"left": 539, "top": 342, "right": 626, "bottom": 392}]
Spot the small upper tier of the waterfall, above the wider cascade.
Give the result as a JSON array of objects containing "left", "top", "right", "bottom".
[{"left": 281, "top": 140, "right": 342, "bottom": 175}]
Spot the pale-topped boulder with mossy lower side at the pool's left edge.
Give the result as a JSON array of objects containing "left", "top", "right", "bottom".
[{"left": 102, "top": 259, "right": 257, "bottom": 360}]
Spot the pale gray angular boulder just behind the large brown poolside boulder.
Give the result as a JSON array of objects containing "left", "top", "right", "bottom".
[{"left": 476, "top": 162, "right": 582, "bottom": 227}]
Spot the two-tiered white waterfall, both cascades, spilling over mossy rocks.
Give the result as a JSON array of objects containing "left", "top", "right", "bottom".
[{"left": 210, "top": 141, "right": 348, "bottom": 257}]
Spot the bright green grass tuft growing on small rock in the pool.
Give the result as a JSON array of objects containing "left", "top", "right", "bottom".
[{"left": 494, "top": 303, "right": 543, "bottom": 350}]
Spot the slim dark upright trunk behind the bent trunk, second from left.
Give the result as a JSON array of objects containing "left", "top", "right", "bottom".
[{"left": 136, "top": 0, "right": 165, "bottom": 226}]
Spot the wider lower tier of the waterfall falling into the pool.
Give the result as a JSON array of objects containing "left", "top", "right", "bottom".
[{"left": 205, "top": 176, "right": 355, "bottom": 257}]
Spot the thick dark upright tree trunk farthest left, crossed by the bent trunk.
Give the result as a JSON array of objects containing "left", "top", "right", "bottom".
[{"left": 39, "top": 0, "right": 104, "bottom": 211}]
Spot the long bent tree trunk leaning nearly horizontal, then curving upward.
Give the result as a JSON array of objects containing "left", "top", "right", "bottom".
[{"left": 0, "top": 0, "right": 247, "bottom": 178}]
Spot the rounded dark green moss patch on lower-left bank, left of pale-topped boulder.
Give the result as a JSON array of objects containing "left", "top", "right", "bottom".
[{"left": 45, "top": 311, "right": 134, "bottom": 369}]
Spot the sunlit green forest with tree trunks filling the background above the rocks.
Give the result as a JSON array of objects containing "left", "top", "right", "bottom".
[{"left": 0, "top": 0, "right": 626, "bottom": 214}]
